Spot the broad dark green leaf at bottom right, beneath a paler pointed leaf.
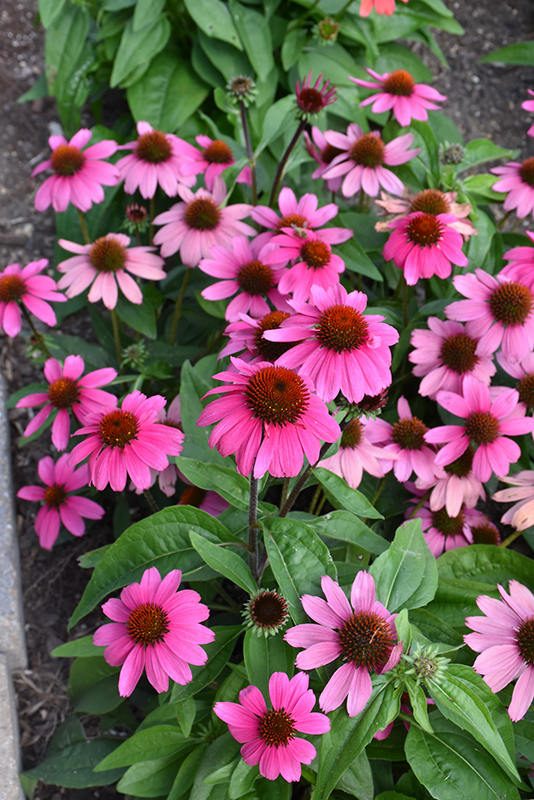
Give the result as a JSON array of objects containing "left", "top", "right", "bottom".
[{"left": 405, "top": 711, "right": 519, "bottom": 800}]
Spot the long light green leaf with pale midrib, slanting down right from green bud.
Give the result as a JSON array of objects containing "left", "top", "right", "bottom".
[{"left": 427, "top": 664, "right": 521, "bottom": 784}]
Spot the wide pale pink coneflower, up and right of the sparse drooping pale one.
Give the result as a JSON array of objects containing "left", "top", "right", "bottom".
[{"left": 154, "top": 177, "right": 256, "bottom": 267}]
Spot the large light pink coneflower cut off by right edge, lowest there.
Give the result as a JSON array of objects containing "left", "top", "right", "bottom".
[{"left": 464, "top": 581, "right": 534, "bottom": 722}]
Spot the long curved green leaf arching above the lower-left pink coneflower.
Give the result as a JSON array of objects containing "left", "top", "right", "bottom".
[{"left": 70, "top": 506, "right": 239, "bottom": 627}]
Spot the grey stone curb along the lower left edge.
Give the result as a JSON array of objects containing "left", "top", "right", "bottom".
[{"left": 0, "top": 374, "right": 27, "bottom": 800}]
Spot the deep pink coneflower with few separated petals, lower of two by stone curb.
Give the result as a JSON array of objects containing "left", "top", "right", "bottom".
[{"left": 17, "top": 453, "right": 105, "bottom": 550}]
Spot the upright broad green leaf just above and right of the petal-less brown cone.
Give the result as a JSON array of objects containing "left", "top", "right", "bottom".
[{"left": 264, "top": 518, "right": 336, "bottom": 624}]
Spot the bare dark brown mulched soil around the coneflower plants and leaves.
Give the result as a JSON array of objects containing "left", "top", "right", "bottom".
[{"left": 0, "top": 0, "right": 534, "bottom": 800}]
